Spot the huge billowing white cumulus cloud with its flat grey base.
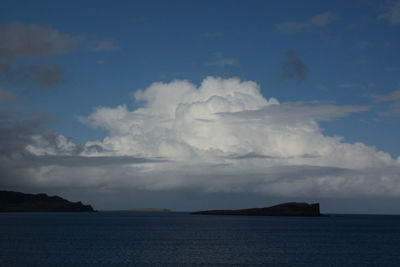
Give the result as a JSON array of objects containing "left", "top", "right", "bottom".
[{"left": 1, "top": 77, "right": 400, "bottom": 201}]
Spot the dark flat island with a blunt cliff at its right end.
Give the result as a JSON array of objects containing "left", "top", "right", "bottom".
[{"left": 192, "top": 202, "right": 321, "bottom": 216}]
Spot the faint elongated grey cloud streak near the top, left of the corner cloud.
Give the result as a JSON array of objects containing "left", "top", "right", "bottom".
[{"left": 276, "top": 12, "right": 337, "bottom": 33}]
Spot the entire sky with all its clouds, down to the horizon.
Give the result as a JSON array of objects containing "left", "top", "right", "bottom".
[{"left": 0, "top": 0, "right": 400, "bottom": 214}]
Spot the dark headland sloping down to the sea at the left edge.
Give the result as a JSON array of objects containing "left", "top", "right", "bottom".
[{"left": 0, "top": 190, "right": 94, "bottom": 212}]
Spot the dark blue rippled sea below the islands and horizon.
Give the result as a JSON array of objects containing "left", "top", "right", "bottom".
[{"left": 0, "top": 212, "right": 400, "bottom": 267}]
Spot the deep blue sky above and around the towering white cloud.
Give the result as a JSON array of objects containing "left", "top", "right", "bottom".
[{"left": 0, "top": 0, "right": 400, "bottom": 213}]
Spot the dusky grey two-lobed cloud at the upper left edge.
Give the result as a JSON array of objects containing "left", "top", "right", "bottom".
[{"left": 0, "top": 22, "right": 83, "bottom": 89}]
